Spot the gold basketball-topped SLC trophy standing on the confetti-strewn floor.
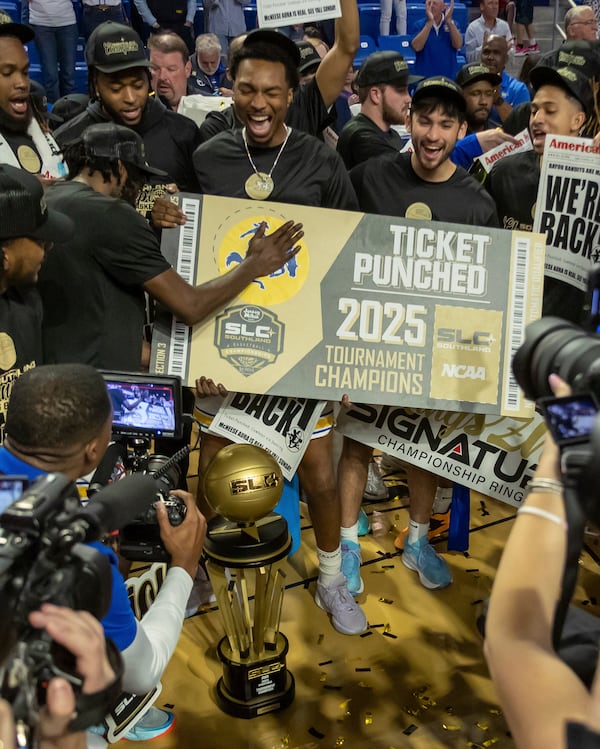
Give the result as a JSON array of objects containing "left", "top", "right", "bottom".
[{"left": 204, "top": 444, "right": 294, "bottom": 718}]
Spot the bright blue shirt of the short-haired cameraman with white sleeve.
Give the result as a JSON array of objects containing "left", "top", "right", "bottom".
[{"left": 0, "top": 447, "right": 137, "bottom": 650}]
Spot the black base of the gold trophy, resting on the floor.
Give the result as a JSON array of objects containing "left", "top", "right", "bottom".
[{"left": 216, "top": 632, "right": 295, "bottom": 718}]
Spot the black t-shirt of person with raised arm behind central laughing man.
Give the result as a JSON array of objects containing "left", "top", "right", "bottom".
[{"left": 200, "top": 78, "right": 336, "bottom": 143}]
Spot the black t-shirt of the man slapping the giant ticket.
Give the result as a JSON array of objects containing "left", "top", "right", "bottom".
[{"left": 38, "top": 182, "right": 171, "bottom": 371}]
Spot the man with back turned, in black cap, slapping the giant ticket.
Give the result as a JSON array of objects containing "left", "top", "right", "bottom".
[{"left": 38, "top": 123, "right": 302, "bottom": 371}]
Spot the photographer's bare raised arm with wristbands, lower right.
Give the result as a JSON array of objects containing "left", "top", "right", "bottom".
[{"left": 484, "top": 375, "right": 599, "bottom": 749}]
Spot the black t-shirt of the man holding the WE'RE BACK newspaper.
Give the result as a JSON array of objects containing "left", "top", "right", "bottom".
[{"left": 485, "top": 151, "right": 585, "bottom": 324}]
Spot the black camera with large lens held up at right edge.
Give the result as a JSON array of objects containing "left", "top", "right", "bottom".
[{"left": 513, "top": 271, "right": 600, "bottom": 525}]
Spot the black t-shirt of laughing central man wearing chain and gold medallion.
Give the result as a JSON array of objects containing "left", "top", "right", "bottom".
[{"left": 194, "top": 130, "right": 358, "bottom": 211}]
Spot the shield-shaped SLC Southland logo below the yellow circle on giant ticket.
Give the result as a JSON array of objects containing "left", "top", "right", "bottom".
[{"left": 214, "top": 305, "right": 284, "bottom": 377}]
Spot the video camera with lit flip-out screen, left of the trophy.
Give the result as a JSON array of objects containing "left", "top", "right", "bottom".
[{"left": 97, "top": 371, "right": 190, "bottom": 562}]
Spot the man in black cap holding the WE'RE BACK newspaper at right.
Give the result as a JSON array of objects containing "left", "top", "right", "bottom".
[{"left": 485, "top": 60, "right": 598, "bottom": 323}]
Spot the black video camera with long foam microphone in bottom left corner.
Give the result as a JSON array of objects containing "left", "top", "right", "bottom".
[{"left": 0, "top": 473, "right": 156, "bottom": 746}]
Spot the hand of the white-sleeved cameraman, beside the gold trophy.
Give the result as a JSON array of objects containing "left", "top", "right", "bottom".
[{"left": 156, "top": 489, "right": 206, "bottom": 580}]
